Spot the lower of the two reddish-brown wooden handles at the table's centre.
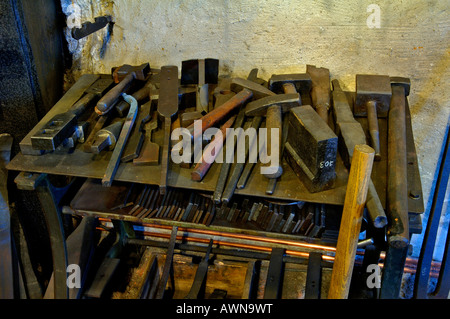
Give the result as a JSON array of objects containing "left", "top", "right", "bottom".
[{"left": 191, "top": 116, "right": 236, "bottom": 182}]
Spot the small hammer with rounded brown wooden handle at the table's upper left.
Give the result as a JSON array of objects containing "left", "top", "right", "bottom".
[{"left": 95, "top": 63, "right": 150, "bottom": 115}]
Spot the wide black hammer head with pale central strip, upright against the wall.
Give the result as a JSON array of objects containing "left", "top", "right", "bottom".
[{"left": 180, "top": 59, "right": 219, "bottom": 85}]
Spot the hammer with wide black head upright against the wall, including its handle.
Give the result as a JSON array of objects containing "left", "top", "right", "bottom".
[{"left": 180, "top": 59, "right": 219, "bottom": 115}]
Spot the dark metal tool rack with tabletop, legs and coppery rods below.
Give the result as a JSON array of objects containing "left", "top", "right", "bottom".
[{"left": 7, "top": 74, "right": 424, "bottom": 298}]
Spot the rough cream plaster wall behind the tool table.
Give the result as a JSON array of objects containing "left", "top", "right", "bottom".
[{"left": 61, "top": 0, "right": 450, "bottom": 258}]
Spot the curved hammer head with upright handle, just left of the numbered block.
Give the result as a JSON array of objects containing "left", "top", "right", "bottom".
[{"left": 245, "top": 93, "right": 300, "bottom": 116}]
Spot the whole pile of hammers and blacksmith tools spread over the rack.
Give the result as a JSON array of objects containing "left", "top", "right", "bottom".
[{"left": 31, "top": 59, "right": 410, "bottom": 247}]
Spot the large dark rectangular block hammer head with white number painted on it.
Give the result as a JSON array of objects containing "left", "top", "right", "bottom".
[{"left": 285, "top": 105, "right": 338, "bottom": 193}]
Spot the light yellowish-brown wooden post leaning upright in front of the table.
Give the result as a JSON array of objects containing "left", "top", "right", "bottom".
[{"left": 328, "top": 145, "right": 375, "bottom": 299}]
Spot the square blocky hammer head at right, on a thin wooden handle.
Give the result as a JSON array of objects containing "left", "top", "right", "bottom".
[{"left": 353, "top": 74, "right": 392, "bottom": 117}]
